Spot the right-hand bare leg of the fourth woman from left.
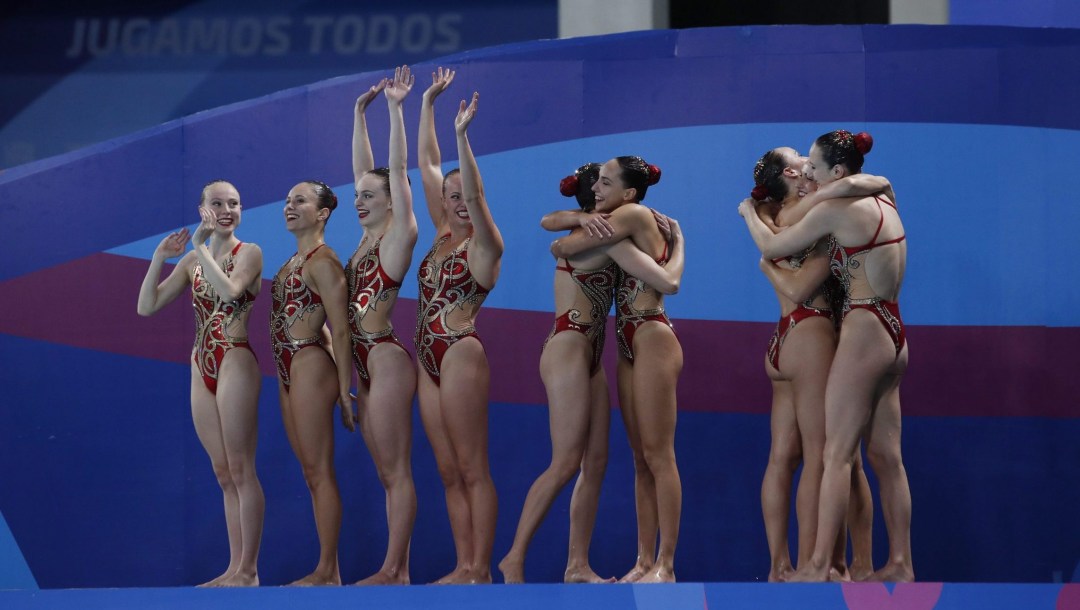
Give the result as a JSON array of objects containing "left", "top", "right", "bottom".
[{"left": 440, "top": 337, "right": 499, "bottom": 583}]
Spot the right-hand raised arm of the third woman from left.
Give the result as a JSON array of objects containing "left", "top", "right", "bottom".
[{"left": 383, "top": 66, "right": 417, "bottom": 277}]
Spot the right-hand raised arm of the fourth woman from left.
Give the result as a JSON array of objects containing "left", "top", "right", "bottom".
[{"left": 454, "top": 93, "right": 503, "bottom": 286}]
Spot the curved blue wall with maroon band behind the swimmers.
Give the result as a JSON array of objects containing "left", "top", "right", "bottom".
[{"left": 0, "top": 26, "right": 1080, "bottom": 587}]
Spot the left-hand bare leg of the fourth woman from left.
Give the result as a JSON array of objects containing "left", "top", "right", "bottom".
[{"left": 417, "top": 367, "right": 473, "bottom": 584}]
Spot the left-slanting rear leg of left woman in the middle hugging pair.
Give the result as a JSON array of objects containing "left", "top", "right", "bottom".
[{"left": 499, "top": 333, "right": 591, "bottom": 584}]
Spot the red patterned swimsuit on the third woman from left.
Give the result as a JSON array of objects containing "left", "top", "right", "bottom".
[{"left": 345, "top": 235, "right": 408, "bottom": 388}]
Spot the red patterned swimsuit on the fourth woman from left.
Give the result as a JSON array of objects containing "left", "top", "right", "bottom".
[{"left": 415, "top": 233, "right": 490, "bottom": 385}]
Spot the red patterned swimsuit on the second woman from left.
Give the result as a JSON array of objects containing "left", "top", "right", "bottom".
[{"left": 270, "top": 244, "right": 326, "bottom": 392}]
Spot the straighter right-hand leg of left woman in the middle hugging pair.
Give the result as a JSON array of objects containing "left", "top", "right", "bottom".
[{"left": 563, "top": 367, "right": 615, "bottom": 583}]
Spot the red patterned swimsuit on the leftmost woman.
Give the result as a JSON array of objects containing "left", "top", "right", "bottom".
[{"left": 191, "top": 242, "right": 255, "bottom": 394}]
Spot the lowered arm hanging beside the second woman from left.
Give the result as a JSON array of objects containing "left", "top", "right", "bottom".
[{"left": 307, "top": 255, "right": 356, "bottom": 432}]
